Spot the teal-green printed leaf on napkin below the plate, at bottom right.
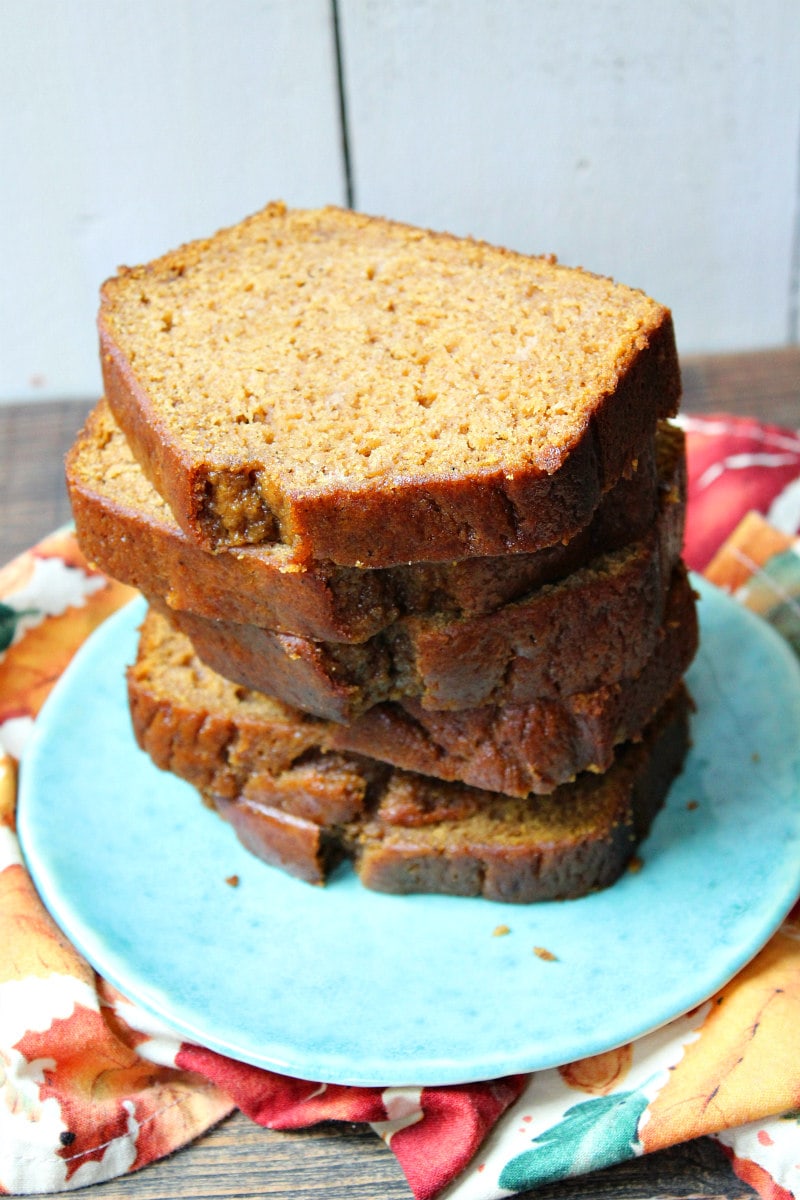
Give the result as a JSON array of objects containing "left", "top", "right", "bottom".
[{"left": 499, "top": 1092, "right": 648, "bottom": 1192}]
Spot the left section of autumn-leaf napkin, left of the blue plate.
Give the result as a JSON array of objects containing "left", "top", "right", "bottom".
[{"left": 0, "top": 533, "right": 234, "bottom": 1194}]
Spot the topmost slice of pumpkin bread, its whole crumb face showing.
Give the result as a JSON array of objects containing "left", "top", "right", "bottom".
[{"left": 98, "top": 204, "right": 680, "bottom": 566}]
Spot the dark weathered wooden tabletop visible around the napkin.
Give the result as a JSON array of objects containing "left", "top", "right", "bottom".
[{"left": 0, "top": 347, "right": 800, "bottom": 1200}]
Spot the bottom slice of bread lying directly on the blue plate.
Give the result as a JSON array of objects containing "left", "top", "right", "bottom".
[{"left": 215, "top": 689, "right": 690, "bottom": 904}]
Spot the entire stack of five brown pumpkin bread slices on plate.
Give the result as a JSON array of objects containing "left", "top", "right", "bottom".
[{"left": 67, "top": 204, "right": 697, "bottom": 902}]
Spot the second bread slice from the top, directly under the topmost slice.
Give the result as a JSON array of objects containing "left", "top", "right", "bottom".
[{"left": 66, "top": 403, "right": 685, "bottom": 642}]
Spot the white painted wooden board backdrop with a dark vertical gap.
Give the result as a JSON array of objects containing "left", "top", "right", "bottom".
[{"left": 0, "top": 0, "right": 800, "bottom": 401}]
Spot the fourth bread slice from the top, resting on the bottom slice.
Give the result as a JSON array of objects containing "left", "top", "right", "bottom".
[{"left": 128, "top": 571, "right": 697, "bottom": 796}]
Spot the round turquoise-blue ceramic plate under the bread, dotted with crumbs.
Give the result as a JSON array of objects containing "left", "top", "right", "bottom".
[{"left": 19, "top": 581, "right": 800, "bottom": 1086}]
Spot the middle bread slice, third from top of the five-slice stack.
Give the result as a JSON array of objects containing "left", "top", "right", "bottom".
[{"left": 155, "top": 463, "right": 687, "bottom": 721}]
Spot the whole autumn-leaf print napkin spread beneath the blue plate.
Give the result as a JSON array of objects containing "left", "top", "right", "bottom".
[{"left": 0, "top": 415, "right": 800, "bottom": 1200}]
